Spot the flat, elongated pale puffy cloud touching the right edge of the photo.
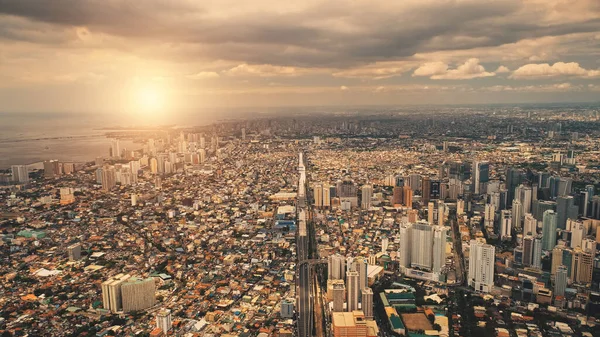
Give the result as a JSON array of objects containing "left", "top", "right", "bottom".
[{"left": 510, "top": 62, "right": 600, "bottom": 79}]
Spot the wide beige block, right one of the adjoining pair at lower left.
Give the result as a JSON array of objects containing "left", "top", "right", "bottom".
[{"left": 121, "top": 277, "right": 156, "bottom": 312}]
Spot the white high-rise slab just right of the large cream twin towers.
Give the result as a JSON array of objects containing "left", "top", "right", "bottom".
[{"left": 469, "top": 240, "right": 496, "bottom": 292}]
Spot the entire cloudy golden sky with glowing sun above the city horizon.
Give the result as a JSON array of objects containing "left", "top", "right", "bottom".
[{"left": 0, "top": 0, "right": 600, "bottom": 113}]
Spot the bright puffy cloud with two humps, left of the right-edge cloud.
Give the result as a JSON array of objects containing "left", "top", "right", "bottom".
[{"left": 413, "top": 58, "right": 496, "bottom": 80}]
